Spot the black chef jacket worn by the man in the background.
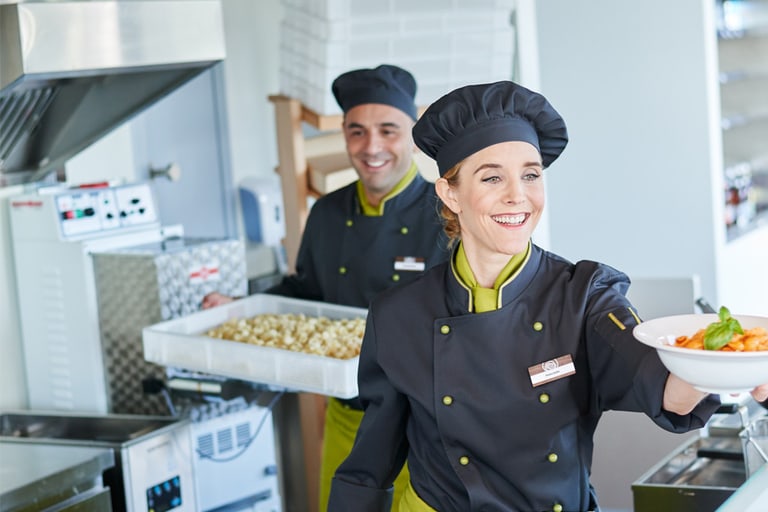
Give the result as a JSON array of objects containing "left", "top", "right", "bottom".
[{"left": 268, "top": 174, "right": 449, "bottom": 308}]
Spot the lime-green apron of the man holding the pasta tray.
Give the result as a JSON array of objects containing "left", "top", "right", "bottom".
[{"left": 319, "top": 398, "right": 411, "bottom": 512}]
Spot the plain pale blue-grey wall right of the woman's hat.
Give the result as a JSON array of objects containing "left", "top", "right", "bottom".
[{"left": 537, "top": 0, "right": 723, "bottom": 300}]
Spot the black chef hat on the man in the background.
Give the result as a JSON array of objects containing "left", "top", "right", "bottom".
[{"left": 331, "top": 64, "right": 416, "bottom": 121}]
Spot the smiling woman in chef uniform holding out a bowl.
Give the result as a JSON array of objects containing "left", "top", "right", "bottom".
[{"left": 329, "top": 81, "right": 768, "bottom": 512}]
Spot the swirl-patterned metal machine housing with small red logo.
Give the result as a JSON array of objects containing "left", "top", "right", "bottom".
[{"left": 93, "top": 239, "right": 248, "bottom": 414}]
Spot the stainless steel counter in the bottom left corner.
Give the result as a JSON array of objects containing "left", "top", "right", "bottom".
[{"left": 0, "top": 441, "right": 115, "bottom": 512}]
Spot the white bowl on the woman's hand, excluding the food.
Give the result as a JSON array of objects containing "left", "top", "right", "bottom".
[{"left": 632, "top": 314, "right": 768, "bottom": 394}]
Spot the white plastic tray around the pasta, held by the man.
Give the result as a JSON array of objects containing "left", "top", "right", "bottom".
[{"left": 142, "top": 294, "right": 367, "bottom": 398}]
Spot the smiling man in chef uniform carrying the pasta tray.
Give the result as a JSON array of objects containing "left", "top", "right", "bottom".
[{"left": 203, "top": 64, "right": 448, "bottom": 510}]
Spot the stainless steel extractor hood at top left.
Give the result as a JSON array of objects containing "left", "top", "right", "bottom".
[{"left": 0, "top": 0, "right": 225, "bottom": 186}]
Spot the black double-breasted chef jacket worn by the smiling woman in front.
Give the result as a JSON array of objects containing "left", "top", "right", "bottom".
[{"left": 329, "top": 246, "right": 719, "bottom": 512}]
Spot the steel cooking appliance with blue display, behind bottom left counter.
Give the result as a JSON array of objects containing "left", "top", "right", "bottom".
[{"left": 0, "top": 411, "right": 198, "bottom": 512}]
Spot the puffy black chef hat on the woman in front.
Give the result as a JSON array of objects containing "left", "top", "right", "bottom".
[{"left": 413, "top": 81, "right": 568, "bottom": 176}]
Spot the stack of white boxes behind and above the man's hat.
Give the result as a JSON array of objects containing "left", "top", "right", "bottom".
[{"left": 280, "top": 0, "right": 516, "bottom": 114}]
